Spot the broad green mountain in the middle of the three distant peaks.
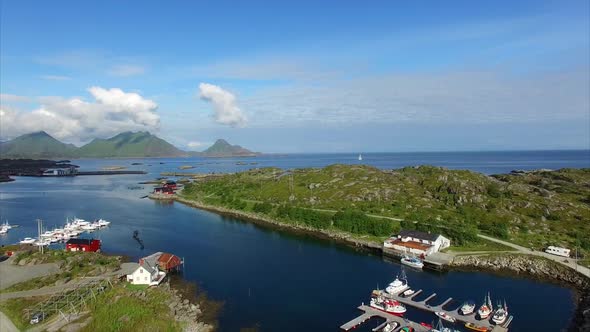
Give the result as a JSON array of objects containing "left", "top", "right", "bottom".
[{"left": 77, "top": 132, "right": 186, "bottom": 158}]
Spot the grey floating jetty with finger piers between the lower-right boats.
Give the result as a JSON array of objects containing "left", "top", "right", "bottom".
[{"left": 340, "top": 304, "right": 512, "bottom": 332}]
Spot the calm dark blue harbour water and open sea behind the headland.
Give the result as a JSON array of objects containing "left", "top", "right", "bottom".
[{"left": 0, "top": 151, "right": 590, "bottom": 331}]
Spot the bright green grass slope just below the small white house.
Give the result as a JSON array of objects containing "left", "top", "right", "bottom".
[{"left": 82, "top": 286, "right": 182, "bottom": 332}]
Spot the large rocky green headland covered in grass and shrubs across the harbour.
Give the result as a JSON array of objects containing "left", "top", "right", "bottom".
[{"left": 181, "top": 165, "right": 590, "bottom": 254}]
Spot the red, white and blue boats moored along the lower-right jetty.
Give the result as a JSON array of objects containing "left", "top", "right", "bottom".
[{"left": 370, "top": 270, "right": 508, "bottom": 332}]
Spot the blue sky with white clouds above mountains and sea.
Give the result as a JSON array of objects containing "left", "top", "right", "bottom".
[{"left": 0, "top": 0, "right": 590, "bottom": 153}]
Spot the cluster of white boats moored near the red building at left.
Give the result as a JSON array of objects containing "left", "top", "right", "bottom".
[{"left": 19, "top": 218, "right": 111, "bottom": 246}]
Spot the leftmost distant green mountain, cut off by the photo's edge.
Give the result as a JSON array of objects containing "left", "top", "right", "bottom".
[{"left": 0, "top": 131, "right": 77, "bottom": 158}]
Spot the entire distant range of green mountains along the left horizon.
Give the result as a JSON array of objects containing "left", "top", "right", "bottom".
[{"left": 0, "top": 131, "right": 256, "bottom": 158}]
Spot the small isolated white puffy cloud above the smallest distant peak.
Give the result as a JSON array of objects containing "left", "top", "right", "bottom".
[{"left": 199, "top": 83, "right": 248, "bottom": 127}]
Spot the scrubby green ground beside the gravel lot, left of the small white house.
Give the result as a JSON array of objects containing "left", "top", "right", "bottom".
[{"left": 1, "top": 250, "right": 121, "bottom": 293}]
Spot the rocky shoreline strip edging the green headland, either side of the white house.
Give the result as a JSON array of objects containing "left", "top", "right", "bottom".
[{"left": 157, "top": 195, "right": 590, "bottom": 331}]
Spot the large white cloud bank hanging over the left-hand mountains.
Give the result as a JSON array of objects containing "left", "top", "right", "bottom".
[{"left": 0, "top": 87, "right": 160, "bottom": 143}]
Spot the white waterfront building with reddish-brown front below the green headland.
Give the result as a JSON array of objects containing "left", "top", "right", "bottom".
[{"left": 383, "top": 230, "right": 451, "bottom": 256}]
